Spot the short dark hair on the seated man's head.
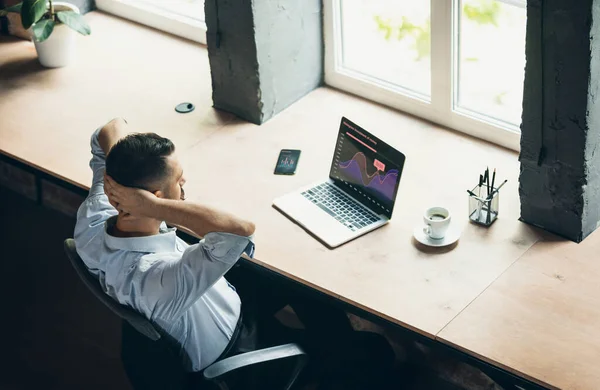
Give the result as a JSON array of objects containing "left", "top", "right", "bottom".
[{"left": 106, "top": 133, "right": 175, "bottom": 191}]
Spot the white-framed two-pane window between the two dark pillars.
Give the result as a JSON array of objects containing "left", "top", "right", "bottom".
[{"left": 325, "top": 0, "right": 526, "bottom": 150}]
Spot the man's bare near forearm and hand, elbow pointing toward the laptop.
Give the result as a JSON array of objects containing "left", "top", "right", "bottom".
[{"left": 105, "top": 176, "right": 255, "bottom": 237}]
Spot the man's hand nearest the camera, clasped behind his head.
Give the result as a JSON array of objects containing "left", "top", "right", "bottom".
[{"left": 104, "top": 175, "right": 158, "bottom": 218}]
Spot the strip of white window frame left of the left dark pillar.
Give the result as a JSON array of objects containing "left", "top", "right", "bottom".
[{"left": 96, "top": 0, "right": 206, "bottom": 45}]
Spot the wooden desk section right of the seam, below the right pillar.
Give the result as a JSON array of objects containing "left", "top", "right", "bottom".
[{"left": 439, "top": 231, "right": 600, "bottom": 389}]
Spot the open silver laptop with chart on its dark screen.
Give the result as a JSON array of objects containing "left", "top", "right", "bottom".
[{"left": 273, "top": 118, "right": 405, "bottom": 248}]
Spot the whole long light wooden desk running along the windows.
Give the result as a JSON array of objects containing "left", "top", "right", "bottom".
[{"left": 0, "top": 13, "right": 600, "bottom": 389}]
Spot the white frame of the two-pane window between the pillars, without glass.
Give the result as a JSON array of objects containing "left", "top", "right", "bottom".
[{"left": 323, "top": 0, "right": 522, "bottom": 151}]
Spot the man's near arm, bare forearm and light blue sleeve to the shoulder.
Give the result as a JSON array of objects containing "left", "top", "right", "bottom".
[{"left": 105, "top": 176, "right": 254, "bottom": 319}]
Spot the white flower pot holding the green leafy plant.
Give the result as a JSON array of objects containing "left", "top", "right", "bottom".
[{"left": 33, "top": 2, "right": 79, "bottom": 68}]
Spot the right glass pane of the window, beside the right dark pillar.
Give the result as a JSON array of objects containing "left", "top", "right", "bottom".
[{"left": 454, "top": 0, "right": 526, "bottom": 126}]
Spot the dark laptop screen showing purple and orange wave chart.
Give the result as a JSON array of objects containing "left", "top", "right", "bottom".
[{"left": 331, "top": 122, "right": 400, "bottom": 211}]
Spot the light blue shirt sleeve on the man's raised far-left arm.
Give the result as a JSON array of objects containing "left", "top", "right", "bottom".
[{"left": 74, "top": 129, "right": 118, "bottom": 254}]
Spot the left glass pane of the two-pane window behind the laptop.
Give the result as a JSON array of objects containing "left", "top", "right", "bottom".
[{"left": 340, "top": 0, "right": 431, "bottom": 100}]
